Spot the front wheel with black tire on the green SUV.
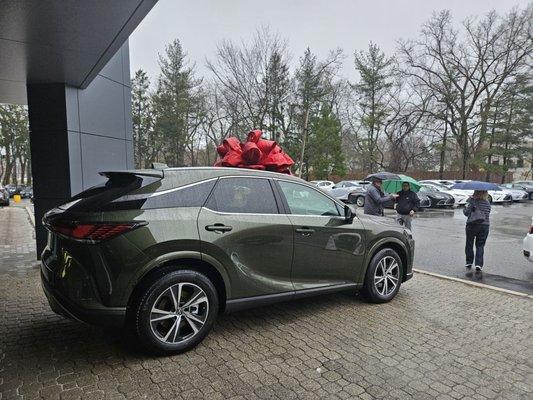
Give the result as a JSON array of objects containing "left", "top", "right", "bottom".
[{"left": 362, "top": 248, "right": 403, "bottom": 303}]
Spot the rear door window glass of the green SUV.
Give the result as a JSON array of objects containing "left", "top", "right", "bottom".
[{"left": 206, "top": 177, "right": 278, "bottom": 214}]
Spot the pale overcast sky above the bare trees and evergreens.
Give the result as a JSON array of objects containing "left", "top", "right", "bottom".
[{"left": 130, "top": 0, "right": 529, "bottom": 80}]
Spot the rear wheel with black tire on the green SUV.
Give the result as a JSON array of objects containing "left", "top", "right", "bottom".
[{"left": 130, "top": 270, "right": 218, "bottom": 355}]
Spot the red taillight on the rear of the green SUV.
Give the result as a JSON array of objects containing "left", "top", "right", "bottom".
[{"left": 47, "top": 221, "right": 146, "bottom": 242}]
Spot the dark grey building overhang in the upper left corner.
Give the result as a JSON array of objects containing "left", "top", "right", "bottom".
[{"left": 0, "top": 0, "right": 157, "bottom": 104}]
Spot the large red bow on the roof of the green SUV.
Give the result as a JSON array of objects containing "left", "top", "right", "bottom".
[{"left": 215, "top": 129, "right": 294, "bottom": 174}]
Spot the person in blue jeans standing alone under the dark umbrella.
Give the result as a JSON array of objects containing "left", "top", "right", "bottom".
[{"left": 463, "top": 190, "right": 490, "bottom": 271}]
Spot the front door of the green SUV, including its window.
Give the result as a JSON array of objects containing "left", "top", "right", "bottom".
[{"left": 276, "top": 180, "right": 365, "bottom": 290}]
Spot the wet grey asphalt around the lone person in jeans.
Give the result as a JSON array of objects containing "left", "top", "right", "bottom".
[{"left": 396, "top": 202, "right": 533, "bottom": 294}]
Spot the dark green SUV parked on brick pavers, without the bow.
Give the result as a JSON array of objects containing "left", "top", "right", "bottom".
[{"left": 41, "top": 168, "right": 414, "bottom": 353}]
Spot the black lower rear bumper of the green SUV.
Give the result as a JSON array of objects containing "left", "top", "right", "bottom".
[{"left": 41, "top": 264, "right": 126, "bottom": 327}]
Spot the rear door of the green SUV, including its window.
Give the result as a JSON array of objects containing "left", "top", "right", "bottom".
[{"left": 198, "top": 177, "right": 293, "bottom": 298}]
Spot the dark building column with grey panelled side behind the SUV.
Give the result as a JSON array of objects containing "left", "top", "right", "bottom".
[{"left": 27, "top": 43, "right": 133, "bottom": 256}]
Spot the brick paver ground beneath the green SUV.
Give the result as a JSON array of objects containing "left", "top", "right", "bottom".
[{"left": 0, "top": 205, "right": 533, "bottom": 400}]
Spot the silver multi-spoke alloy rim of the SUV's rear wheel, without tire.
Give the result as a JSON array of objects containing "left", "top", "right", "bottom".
[{"left": 150, "top": 282, "right": 209, "bottom": 344}]
